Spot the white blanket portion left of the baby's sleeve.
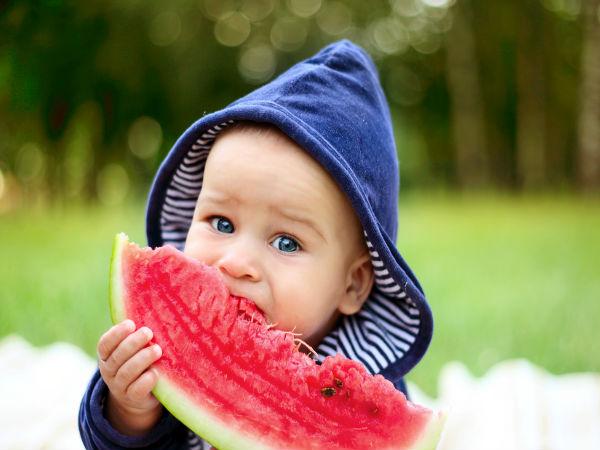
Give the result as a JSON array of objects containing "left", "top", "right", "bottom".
[{"left": 0, "top": 336, "right": 96, "bottom": 450}]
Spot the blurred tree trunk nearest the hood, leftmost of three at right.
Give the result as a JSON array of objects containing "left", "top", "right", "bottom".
[{"left": 446, "top": 0, "right": 490, "bottom": 187}]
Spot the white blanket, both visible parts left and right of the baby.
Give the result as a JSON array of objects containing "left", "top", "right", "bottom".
[{"left": 0, "top": 336, "right": 600, "bottom": 450}]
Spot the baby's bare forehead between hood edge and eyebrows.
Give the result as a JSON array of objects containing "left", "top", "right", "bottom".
[{"left": 203, "top": 126, "right": 364, "bottom": 236}]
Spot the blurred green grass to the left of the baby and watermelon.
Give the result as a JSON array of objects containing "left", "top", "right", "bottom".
[{"left": 0, "top": 205, "right": 145, "bottom": 355}]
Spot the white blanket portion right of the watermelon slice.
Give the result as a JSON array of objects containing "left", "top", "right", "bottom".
[{"left": 409, "top": 360, "right": 600, "bottom": 450}]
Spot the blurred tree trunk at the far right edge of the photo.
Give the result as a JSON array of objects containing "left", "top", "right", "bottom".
[{"left": 578, "top": 0, "right": 600, "bottom": 191}]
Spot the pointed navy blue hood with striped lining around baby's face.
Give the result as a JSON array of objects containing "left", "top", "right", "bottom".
[{"left": 146, "top": 40, "right": 432, "bottom": 383}]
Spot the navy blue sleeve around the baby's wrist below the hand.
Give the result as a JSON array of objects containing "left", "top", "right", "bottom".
[{"left": 79, "top": 370, "right": 188, "bottom": 450}]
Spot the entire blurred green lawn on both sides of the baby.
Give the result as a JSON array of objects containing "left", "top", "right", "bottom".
[{"left": 0, "top": 194, "right": 600, "bottom": 394}]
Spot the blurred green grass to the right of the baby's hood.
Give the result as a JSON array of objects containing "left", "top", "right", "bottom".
[{"left": 399, "top": 192, "right": 600, "bottom": 393}]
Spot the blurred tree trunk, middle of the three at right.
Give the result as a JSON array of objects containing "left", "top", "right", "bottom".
[{"left": 516, "top": 0, "right": 547, "bottom": 189}]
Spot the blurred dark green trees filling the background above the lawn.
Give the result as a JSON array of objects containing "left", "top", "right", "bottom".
[{"left": 0, "top": 0, "right": 600, "bottom": 209}]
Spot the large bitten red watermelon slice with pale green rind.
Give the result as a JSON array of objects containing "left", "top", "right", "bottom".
[{"left": 110, "top": 234, "right": 443, "bottom": 450}]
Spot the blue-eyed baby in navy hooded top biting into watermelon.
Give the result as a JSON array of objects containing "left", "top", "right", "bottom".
[{"left": 80, "top": 40, "right": 432, "bottom": 449}]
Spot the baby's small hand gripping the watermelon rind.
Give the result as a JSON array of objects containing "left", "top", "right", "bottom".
[{"left": 98, "top": 320, "right": 162, "bottom": 435}]
